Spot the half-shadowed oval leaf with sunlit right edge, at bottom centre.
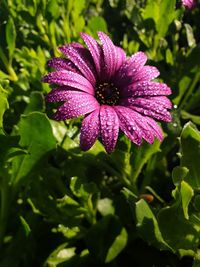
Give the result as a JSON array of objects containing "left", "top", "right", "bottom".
[{"left": 85, "top": 215, "right": 128, "bottom": 263}]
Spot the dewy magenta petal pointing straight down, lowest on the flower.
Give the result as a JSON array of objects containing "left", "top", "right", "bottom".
[{"left": 100, "top": 105, "right": 119, "bottom": 153}]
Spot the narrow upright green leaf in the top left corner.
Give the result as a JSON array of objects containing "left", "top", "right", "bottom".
[{"left": 6, "top": 17, "right": 16, "bottom": 59}]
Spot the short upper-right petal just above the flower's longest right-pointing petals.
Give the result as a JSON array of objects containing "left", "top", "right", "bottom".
[{"left": 132, "top": 66, "right": 160, "bottom": 82}]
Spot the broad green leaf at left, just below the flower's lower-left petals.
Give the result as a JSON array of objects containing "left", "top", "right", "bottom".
[{"left": 12, "top": 112, "right": 56, "bottom": 188}]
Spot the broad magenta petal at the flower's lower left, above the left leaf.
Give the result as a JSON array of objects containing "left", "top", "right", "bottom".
[{"left": 54, "top": 91, "right": 99, "bottom": 120}]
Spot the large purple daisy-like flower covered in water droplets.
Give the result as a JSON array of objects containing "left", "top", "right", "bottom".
[{"left": 43, "top": 32, "right": 171, "bottom": 153}]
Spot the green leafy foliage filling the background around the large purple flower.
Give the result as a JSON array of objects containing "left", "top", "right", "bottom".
[{"left": 0, "top": 0, "right": 200, "bottom": 267}]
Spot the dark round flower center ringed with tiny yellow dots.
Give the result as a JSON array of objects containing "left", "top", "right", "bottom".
[{"left": 95, "top": 83, "right": 119, "bottom": 106}]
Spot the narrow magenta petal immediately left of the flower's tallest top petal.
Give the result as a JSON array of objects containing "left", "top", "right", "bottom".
[{"left": 80, "top": 33, "right": 103, "bottom": 75}]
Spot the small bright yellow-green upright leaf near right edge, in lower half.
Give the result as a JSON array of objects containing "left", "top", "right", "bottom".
[{"left": 180, "top": 181, "right": 194, "bottom": 219}]
